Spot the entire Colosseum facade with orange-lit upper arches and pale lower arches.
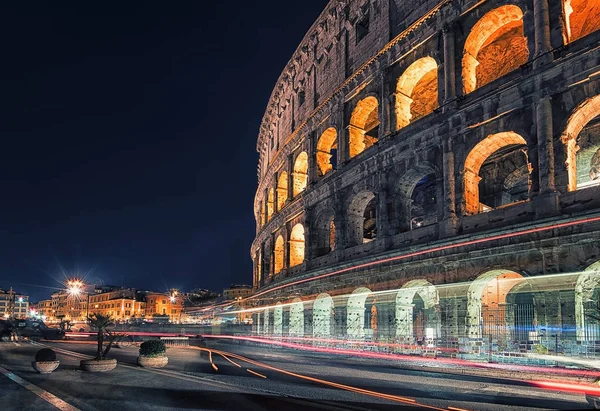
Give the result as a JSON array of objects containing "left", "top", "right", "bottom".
[{"left": 246, "top": 0, "right": 600, "bottom": 358}]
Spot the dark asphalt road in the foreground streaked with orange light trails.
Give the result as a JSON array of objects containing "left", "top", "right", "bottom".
[{"left": 0, "top": 341, "right": 588, "bottom": 411}]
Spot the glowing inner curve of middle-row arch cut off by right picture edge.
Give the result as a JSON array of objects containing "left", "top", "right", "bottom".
[{"left": 561, "top": 95, "right": 600, "bottom": 191}]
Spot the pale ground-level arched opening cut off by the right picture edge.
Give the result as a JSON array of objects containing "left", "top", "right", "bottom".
[{"left": 575, "top": 261, "right": 600, "bottom": 341}]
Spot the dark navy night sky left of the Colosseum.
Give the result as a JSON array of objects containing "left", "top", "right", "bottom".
[{"left": 0, "top": 0, "right": 327, "bottom": 301}]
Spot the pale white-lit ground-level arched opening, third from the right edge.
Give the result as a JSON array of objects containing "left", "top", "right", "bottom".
[{"left": 396, "top": 279, "right": 441, "bottom": 344}]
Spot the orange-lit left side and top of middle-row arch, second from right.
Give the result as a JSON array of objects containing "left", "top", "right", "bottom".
[{"left": 464, "top": 131, "right": 527, "bottom": 214}]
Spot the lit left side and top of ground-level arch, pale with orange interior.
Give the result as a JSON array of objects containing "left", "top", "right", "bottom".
[{"left": 467, "top": 269, "right": 526, "bottom": 338}]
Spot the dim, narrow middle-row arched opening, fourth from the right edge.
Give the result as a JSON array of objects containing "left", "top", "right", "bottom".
[{"left": 347, "top": 191, "right": 377, "bottom": 246}]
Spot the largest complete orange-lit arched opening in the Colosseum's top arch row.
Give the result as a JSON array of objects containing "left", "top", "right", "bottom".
[{"left": 462, "top": 5, "right": 529, "bottom": 94}]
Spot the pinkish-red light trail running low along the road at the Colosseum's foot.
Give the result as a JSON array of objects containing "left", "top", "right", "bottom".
[{"left": 203, "top": 335, "right": 600, "bottom": 378}]
